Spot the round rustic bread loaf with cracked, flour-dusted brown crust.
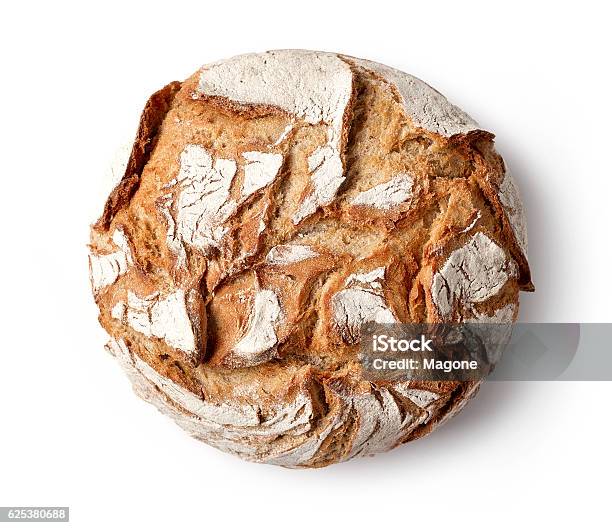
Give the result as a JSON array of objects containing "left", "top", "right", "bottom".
[{"left": 90, "top": 50, "right": 533, "bottom": 467}]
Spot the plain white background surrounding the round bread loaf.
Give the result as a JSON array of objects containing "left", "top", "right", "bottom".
[{"left": 0, "top": 0, "right": 612, "bottom": 527}]
